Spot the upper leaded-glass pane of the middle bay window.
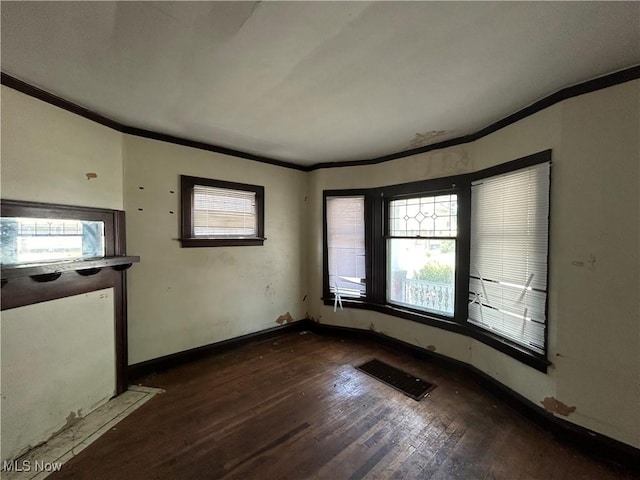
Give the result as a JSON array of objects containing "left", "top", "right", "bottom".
[{"left": 389, "top": 195, "right": 458, "bottom": 237}]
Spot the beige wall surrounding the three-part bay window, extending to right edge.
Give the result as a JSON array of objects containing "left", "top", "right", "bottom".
[{"left": 308, "top": 81, "right": 640, "bottom": 447}]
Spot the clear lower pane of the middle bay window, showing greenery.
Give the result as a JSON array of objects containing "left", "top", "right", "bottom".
[{"left": 387, "top": 238, "right": 456, "bottom": 317}]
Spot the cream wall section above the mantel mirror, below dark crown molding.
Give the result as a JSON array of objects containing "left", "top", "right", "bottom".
[{"left": 1, "top": 86, "right": 122, "bottom": 209}]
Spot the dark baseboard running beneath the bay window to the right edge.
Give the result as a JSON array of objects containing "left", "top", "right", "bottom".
[{"left": 300, "top": 320, "right": 640, "bottom": 472}]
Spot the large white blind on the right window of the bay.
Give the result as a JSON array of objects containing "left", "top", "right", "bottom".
[{"left": 469, "top": 162, "right": 550, "bottom": 353}]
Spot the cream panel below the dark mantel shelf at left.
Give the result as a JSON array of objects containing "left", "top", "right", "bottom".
[{"left": 0, "top": 288, "right": 116, "bottom": 460}]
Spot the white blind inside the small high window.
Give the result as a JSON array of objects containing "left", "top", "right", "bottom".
[{"left": 193, "top": 185, "right": 257, "bottom": 238}]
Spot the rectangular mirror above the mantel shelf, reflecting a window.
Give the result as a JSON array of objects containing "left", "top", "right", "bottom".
[{"left": 0, "top": 217, "right": 105, "bottom": 265}]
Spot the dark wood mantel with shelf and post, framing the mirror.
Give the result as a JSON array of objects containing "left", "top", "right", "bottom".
[{"left": 0, "top": 200, "right": 140, "bottom": 395}]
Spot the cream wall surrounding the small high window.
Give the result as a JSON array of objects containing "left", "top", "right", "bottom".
[{"left": 124, "top": 136, "right": 307, "bottom": 364}]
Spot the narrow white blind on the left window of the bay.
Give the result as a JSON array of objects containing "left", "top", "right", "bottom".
[{"left": 326, "top": 196, "right": 366, "bottom": 298}]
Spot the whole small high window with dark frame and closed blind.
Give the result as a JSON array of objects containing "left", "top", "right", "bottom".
[{"left": 180, "top": 175, "right": 265, "bottom": 247}]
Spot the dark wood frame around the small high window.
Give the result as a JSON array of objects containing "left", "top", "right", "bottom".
[{"left": 180, "top": 175, "right": 266, "bottom": 247}]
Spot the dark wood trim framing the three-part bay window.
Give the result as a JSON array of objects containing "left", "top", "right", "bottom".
[{"left": 322, "top": 150, "right": 551, "bottom": 373}]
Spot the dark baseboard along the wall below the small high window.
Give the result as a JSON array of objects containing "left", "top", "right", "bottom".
[{"left": 127, "top": 320, "right": 308, "bottom": 383}]
